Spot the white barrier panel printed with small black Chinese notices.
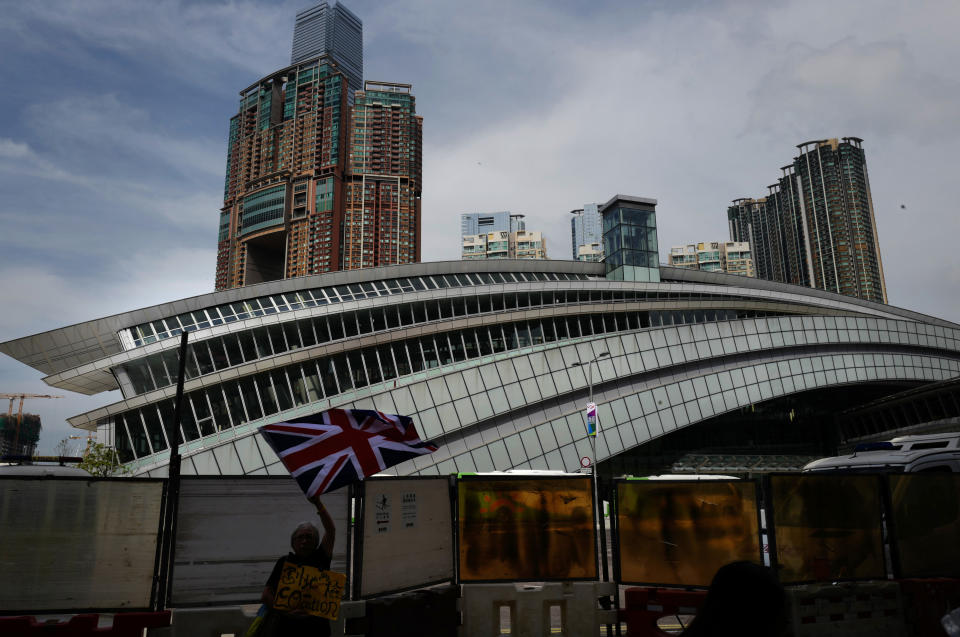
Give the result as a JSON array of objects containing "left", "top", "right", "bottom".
[{"left": 355, "top": 476, "right": 454, "bottom": 597}]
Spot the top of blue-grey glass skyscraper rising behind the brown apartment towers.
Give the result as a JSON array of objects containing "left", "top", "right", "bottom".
[{"left": 290, "top": 2, "right": 363, "bottom": 104}]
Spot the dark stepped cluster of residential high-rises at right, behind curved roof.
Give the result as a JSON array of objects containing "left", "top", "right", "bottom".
[{"left": 727, "top": 137, "right": 887, "bottom": 303}]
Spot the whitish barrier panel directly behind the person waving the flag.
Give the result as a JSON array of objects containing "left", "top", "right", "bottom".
[{"left": 172, "top": 476, "right": 349, "bottom": 607}]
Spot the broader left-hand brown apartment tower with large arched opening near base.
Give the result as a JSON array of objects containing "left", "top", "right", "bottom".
[{"left": 216, "top": 57, "right": 348, "bottom": 290}]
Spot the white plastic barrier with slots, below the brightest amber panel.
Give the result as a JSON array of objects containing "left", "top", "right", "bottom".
[{"left": 460, "top": 582, "right": 617, "bottom": 637}]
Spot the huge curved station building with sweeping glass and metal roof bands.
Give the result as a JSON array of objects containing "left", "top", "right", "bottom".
[{"left": 0, "top": 260, "right": 960, "bottom": 475}]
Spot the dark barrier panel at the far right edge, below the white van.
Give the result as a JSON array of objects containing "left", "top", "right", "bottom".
[{"left": 887, "top": 473, "right": 960, "bottom": 578}]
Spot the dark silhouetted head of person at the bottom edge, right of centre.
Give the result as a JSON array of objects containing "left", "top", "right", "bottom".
[{"left": 683, "top": 562, "right": 787, "bottom": 637}]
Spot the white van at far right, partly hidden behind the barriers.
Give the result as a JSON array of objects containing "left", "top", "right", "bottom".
[{"left": 803, "top": 432, "right": 960, "bottom": 473}]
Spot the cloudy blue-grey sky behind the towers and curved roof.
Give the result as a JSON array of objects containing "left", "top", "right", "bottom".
[{"left": 0, "top": 0, "right": 960, "bottom": 453}]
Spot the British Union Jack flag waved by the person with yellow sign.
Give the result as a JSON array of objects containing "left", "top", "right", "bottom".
[{"left": 260, "top": 409, "right": 437, "bottom": 498}]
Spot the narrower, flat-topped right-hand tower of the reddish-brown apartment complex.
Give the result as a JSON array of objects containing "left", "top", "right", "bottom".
[{"left": 343, "top": 82, "right": 423, "bottom": 270}]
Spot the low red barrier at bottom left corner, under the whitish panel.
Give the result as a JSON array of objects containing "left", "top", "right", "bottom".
[{"left": 0, "top": 611, "right": 170, "bottom": 637}]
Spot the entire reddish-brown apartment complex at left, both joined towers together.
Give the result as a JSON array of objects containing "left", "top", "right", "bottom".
[{"left": 216, "top": 67, "right": 423, "bottom": 290}]
